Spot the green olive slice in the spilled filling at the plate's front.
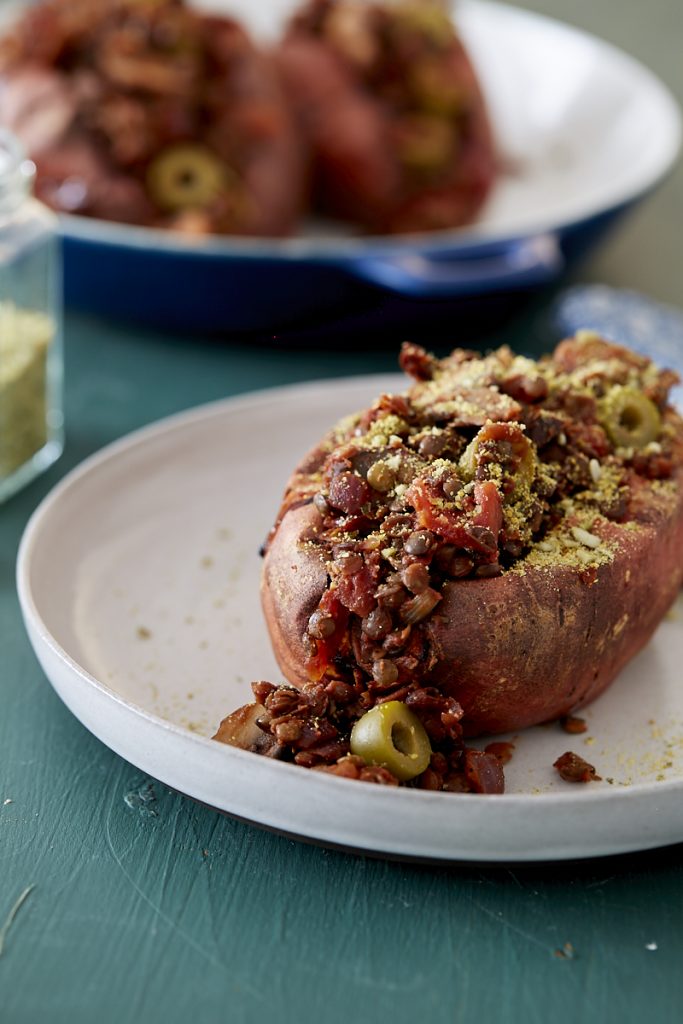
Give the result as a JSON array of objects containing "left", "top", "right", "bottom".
[{"left": 351, "top": 700, "right": 432, "bottom": 782}]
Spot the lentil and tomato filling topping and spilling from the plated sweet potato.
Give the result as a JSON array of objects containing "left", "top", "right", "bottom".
[{"left": 216, "top": 331, "right": 681, "bottom": 793}]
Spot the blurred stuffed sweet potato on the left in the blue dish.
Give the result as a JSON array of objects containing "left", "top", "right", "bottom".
[{"left": 0, "top": 0, "right": 306, "bottom": 236}]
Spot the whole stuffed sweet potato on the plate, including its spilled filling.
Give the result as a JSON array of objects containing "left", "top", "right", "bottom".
[{"left": 215, "top": 331, "right": 683, "bottom": 794}]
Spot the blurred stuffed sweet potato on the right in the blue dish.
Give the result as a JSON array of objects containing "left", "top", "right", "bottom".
[{"left": 276, "top": 0, "right": 496, "bottom": 232}]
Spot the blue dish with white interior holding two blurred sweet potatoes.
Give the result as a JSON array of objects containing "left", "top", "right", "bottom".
[{"left": 56, "top": 0, "right": 681, "bottom": 333}]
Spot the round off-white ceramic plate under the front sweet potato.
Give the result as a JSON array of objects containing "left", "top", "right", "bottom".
[{"left": 17, "top": 377, "right": 683, "bottom": 861}]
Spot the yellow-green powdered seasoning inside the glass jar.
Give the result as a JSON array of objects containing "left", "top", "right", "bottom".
[{"left": 0, "top": 301, "right": 54, "bottom": 478}]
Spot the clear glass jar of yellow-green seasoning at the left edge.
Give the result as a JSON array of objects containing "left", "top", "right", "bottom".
[{"left": 0, "top": 129, "right": 63, "bottom": 501}]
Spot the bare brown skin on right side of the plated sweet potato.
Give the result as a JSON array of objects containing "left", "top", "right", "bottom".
[{"left": 427, "top": 473, "right": 683, "bottom": 735}]
